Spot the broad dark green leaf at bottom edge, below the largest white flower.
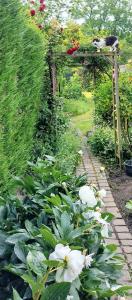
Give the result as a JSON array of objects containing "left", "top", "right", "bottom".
[{"left": 40, "top": 282, "right": 71, "bottom": 300}]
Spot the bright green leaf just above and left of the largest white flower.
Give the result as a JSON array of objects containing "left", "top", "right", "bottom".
[{"left": 40, "top": 228, "right": 57, "bottom": 248}]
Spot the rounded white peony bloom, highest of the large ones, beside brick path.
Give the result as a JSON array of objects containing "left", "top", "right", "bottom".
[{"left": 79, "top": 185, "right": 97, "bottom": 207}]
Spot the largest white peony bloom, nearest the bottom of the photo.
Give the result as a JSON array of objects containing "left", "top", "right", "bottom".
[{"left": 49, "top": 244, "right": 85, "bottom": 282}]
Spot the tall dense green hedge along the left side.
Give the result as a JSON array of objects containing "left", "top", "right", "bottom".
[{"left": 0, "top": 0, "right": 45, "bottom": 189}]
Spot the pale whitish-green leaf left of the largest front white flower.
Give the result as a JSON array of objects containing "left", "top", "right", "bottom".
[{"left": 27, "top": 250, "right": 47, "bottom": 276}]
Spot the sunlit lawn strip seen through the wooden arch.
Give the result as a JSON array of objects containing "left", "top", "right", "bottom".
[{"left": 72, "top": 92, "right": 94, "bottom": 135}]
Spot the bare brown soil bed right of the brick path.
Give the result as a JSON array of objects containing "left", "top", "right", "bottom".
[{"left": 108, "top": 170, "right": 132, "bottom": 233}]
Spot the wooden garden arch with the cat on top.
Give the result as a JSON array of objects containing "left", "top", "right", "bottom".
[{"left": 50, "top": 51, "right": 122, "bottom": 168}]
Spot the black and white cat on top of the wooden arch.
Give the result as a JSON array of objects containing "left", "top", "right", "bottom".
[{"left": 92, "top": 35, "right": 119, "bottom": 52}]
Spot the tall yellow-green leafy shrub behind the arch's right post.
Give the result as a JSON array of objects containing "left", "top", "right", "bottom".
[{"left": 94, "top": 74, "right": 132, "bottom": 127}]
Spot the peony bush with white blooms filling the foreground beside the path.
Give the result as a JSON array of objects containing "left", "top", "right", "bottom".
[{"left": 0, "top": 156, "right": 132, "bottom": 300}]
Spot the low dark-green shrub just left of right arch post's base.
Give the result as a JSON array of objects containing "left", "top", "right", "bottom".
[{"left": 88, "top": 127, "right": 115, "bottom": 159}]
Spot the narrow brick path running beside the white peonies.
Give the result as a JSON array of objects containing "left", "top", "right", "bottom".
[{"left": 77, "top": 143, "right": 132, "bottom": 299}]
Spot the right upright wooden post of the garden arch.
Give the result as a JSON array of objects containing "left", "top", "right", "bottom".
[{"left": 112, "top": 53, "right": 122, "bottom": 168}]
